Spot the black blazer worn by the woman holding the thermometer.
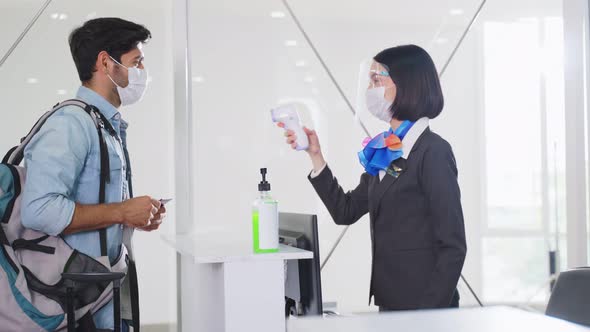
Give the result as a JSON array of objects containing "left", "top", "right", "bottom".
[{"left": 309, "top": 128, "right": 467, "bottom": 310}]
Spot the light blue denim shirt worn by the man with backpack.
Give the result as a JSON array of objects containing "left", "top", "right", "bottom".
[{"left": 21, "top": 87, "right": 129, "bottom": 329}]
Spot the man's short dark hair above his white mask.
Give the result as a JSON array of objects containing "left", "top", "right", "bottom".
[{"left": 69, "top": 18, "right": 152, "bottom": 82}]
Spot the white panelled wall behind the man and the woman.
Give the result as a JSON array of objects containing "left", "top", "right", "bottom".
[{"left": 0, "top": 0, "right": 580, "bottom": 323}]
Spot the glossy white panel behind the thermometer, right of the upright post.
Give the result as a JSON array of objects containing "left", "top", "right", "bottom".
[{"left": 190, "top": 0, "right": 490, "bottom": 312}]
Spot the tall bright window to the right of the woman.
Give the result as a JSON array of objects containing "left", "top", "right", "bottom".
[{"left": 482, "top": 17, "right": 565, "bottom": 303}]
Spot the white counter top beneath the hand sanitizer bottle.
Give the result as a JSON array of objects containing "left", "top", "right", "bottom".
[{"left": 162, "top": 233, "right": 313, "bottom": 264}]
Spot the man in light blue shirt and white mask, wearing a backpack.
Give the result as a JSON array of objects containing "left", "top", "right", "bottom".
[{"left": 22, "top": 18, "right": 166, "bottom": 331}]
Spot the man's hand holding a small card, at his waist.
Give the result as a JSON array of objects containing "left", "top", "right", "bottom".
[{"left": 121, "top": 196, "right": 161, "bottom": 228}]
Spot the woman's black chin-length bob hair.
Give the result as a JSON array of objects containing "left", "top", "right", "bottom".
[{"left": 373, "top": 45, "right": 444, "bottom": 121}]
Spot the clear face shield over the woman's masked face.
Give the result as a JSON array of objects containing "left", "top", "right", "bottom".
[{"left": 356, "top": 59, "right": 395, "bottom": 123}]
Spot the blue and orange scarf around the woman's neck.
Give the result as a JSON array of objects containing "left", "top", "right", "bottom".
[{"left": 358, "top": 121, "right": 414, "bottom": 176}]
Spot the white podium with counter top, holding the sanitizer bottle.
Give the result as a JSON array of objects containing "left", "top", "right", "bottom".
[{"left": 163, "top": 234, "right": 313, "bottom": 332}]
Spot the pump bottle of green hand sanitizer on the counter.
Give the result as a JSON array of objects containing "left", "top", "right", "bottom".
[{"left": 252, "top": 168, "right": 279, "bottom": 254}]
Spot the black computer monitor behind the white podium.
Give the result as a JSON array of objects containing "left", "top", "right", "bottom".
[{"left": 279, "top": 212, "right": 323, "bottom": 316}]
